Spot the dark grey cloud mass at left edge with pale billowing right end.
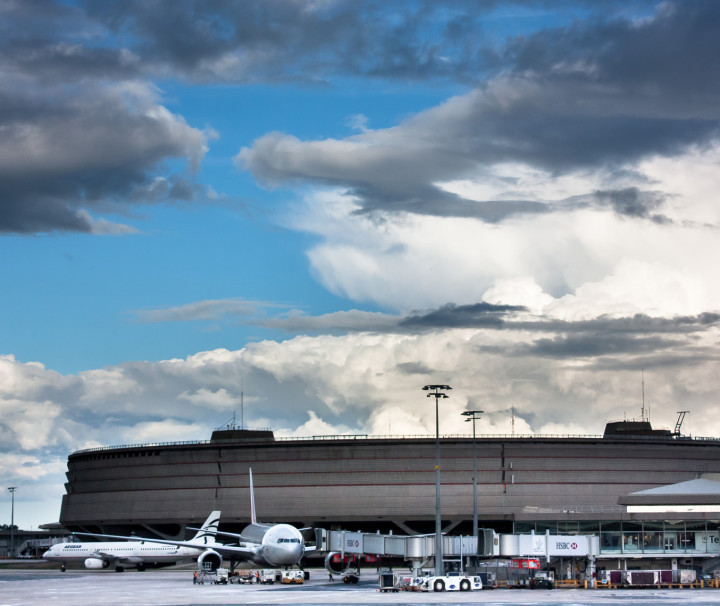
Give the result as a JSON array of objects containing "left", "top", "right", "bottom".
[{"left": 0, "top": 77, "right": 208, "bottom": 233}]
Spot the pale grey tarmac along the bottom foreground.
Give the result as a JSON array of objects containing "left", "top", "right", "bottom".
[{"left": 0, "top": 569, "right": 720, "bottom": 606}]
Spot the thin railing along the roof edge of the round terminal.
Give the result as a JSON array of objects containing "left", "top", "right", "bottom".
[{"left": 72, "top": 433, "right": 720, "bottom": 455}]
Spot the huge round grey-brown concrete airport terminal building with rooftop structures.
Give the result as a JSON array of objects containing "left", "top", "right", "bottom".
[{"left": 60, "top": 422, "right": 720, "bottom": 557}]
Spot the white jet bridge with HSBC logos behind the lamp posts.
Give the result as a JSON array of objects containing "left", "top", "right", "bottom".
[{"left": 316, "top": 529, "right": 600, "bottom": 573}]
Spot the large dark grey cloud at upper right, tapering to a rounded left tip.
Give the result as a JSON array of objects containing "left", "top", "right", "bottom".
[{"left": 237, "top": 2, "right": 720, "bottom": 223}]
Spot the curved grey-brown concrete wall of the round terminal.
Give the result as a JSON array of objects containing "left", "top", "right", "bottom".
[{"left": 60, "top": 437, "right": 720, "bottom": 534}]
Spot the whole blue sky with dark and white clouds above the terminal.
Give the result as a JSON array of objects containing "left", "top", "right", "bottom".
[{"left": 0, "top": 0, "right": 720, "bottom": 528}]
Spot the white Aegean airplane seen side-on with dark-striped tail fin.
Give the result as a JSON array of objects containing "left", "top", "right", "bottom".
[{"left": 43, "top": 511, "right": 220, "bottom": 572}]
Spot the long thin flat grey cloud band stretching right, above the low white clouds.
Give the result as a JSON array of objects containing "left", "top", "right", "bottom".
[{"left": 143, "top": 299, "right": 720, "bottom": 344}]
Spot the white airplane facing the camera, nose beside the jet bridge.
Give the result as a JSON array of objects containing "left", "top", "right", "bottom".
[{"left": 66, "top": 469, "right": 315, "bottom": 572}]
